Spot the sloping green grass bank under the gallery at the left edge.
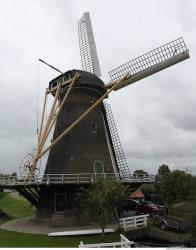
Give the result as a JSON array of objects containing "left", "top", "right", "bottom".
[{"left": 0, "top": 194, "right": 34, "bottom": 219}]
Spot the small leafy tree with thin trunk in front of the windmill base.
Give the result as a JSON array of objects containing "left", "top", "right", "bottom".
[{"left": 76, "top": 181, "right": 129, "bottom": 237}]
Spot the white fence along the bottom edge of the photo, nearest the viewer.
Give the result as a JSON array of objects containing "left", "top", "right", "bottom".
[{"left": 78, "top": 234, "right": 134, "bottom": 248}]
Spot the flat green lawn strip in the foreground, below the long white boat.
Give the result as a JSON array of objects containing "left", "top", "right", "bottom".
[{"left": 0, "top": 229, "right": 120, "bottom": 247}]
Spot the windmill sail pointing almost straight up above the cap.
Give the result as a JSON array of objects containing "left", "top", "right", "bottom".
[{"left": 78, "top": 12, "right": 101, "bottom": 77}]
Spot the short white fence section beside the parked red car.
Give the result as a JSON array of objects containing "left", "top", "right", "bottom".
[{"left": 119, "top": 214, "right": 149, "bottom": 231}]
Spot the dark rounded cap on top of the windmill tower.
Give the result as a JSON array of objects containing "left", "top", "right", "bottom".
[{"left": 49, "top": 69, "right": 106, "bottom": 92}]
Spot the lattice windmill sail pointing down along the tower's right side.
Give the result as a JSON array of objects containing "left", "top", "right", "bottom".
[{"left": 103, "top": 102, "right": 131, "bottom": 177}]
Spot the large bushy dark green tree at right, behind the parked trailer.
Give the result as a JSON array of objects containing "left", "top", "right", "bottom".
[{"left": 160, "top": 170, "right": 194, "bottom": 203}]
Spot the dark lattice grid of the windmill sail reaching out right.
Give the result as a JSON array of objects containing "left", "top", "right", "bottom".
[{"left": 108, "top": 37, "right": 188, "bottom": 81}]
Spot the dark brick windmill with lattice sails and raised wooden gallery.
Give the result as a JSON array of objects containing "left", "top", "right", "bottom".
[{"left": 0, "top": 12, "right": 189, "bottom": 225}]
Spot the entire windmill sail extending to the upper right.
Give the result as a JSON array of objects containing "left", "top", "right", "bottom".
[{"left": 106, "top": 37, "right": 190, "bottom": 90}]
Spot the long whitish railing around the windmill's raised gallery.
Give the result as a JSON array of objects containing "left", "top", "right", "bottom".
[{"left": 0, "top": 173, "right": 155, "bottom": 186}]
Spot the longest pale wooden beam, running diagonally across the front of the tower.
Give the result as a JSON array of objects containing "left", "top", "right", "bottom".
[{"left": 36, "top": 75, "right": 128, "bottom": 160}]
